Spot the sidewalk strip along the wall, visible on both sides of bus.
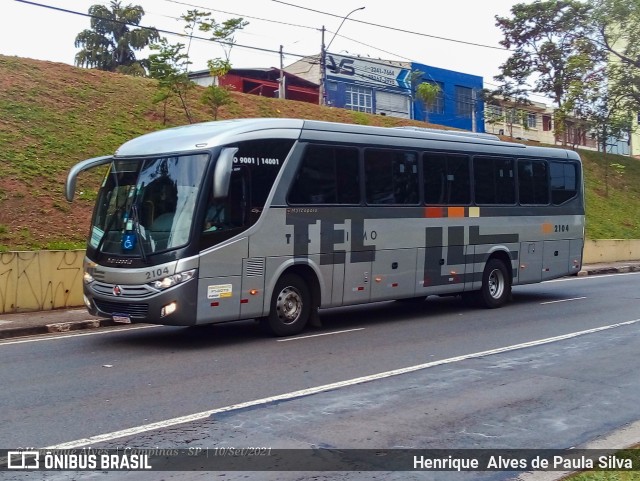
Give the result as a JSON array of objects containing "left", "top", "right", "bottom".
[{"left": 0, "top": 261, "right": 640, "bottom": 340}]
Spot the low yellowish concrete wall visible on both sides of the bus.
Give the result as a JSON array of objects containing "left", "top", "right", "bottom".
[{"left": 0, "top": 239, "right": 640, "bottom": 314}]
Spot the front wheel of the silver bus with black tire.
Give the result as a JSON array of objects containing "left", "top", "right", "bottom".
[{"left": 263, "top": 274, "right": 311, "bottom": 336}]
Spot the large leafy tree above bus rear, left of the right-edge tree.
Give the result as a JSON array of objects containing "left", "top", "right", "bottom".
[{"left": 496, "top": 0, "right": 604, "bottom": 141}]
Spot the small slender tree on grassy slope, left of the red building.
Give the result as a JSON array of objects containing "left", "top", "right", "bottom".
[{"left": 149, "top": 38, "right": 194, "bottom": 123}]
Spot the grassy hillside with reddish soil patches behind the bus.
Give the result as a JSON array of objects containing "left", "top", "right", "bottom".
[{"left": 0, "top": 55, "right": 640, "bottom": 251}]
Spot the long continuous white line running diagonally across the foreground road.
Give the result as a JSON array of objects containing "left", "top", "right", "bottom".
[{"left": 41, "top": 319, "right": 640, "bottom": 449}]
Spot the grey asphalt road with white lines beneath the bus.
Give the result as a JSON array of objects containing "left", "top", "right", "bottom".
[{"left": 0, "top": 273, "right": 640, "bottom": 479}]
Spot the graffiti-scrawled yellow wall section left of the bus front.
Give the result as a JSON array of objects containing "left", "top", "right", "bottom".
[{"left": 0, "top": 250, "right": 84, "bottom": 314}]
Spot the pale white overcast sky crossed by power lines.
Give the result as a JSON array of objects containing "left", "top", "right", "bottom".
[{"left": 0, "top": 0, "right": 531, "bottom": 96}]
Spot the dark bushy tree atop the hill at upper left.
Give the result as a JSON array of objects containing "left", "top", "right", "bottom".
[{"left": 75, "top": 0, "right": 160, "bottom": 75}]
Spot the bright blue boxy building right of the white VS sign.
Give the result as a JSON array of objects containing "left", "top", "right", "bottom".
[{"left": 411, "top": 62, "right": 484, "bottom": 132}]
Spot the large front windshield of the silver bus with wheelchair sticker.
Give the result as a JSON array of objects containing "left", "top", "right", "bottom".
[{"left": 89, "top": 154, "right": 209, "bottom": 259}]
